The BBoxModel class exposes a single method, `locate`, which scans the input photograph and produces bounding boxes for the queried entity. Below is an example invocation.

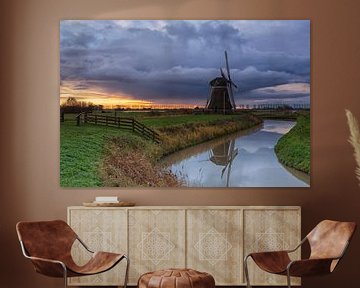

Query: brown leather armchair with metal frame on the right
[244,220,356,288]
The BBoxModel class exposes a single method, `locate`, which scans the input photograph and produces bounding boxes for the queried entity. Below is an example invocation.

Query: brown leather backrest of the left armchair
[16,220,76,260]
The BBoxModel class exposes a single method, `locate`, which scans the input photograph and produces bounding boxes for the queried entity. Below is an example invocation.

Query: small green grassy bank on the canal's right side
[275,115,310,174]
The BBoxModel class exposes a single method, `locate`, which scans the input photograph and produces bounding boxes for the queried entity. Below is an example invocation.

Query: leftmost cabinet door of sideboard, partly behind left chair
[68,209,127,286]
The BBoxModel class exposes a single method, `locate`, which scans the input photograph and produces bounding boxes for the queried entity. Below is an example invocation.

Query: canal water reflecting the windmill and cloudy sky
[162,120,310,187]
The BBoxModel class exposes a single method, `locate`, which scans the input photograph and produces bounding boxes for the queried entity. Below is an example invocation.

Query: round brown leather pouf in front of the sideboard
[138,269,215,288]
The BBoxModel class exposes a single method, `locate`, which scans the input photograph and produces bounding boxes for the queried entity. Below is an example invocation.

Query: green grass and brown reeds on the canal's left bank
[60,114,261,187]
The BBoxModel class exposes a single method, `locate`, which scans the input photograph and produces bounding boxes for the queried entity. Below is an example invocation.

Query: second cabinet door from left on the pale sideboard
[129,209,185,284]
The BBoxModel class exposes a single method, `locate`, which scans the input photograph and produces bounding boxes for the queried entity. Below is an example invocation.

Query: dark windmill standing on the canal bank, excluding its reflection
[206,51,237,113]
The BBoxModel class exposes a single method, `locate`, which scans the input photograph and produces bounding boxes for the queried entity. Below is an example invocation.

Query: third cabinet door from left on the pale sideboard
[186,209,243,285]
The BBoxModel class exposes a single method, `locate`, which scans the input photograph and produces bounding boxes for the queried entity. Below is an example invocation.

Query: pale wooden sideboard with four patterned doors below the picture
[68,206,301,286]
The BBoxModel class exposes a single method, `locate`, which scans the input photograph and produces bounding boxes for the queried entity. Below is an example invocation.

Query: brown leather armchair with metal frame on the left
[16,220,129,288]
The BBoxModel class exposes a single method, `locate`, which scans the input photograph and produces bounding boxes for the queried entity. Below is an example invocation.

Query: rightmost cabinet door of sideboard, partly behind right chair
[244,209,301,285]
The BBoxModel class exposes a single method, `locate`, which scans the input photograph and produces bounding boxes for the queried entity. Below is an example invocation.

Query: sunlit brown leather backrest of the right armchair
[306,220,356,260]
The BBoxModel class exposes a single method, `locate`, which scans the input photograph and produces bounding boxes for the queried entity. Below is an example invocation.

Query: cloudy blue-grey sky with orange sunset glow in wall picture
[60,20,310,106]
